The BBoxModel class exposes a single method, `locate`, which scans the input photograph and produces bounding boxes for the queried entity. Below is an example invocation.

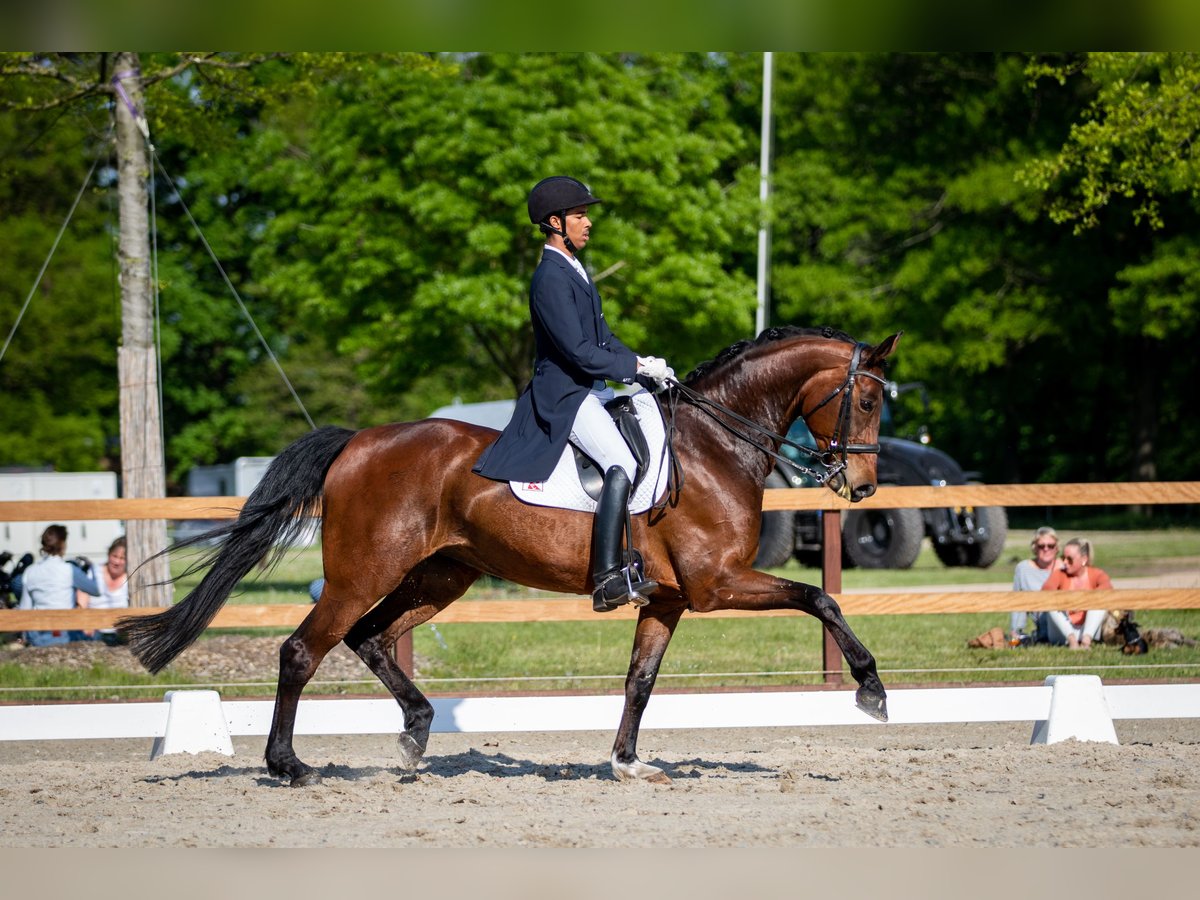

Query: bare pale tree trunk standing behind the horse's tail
[115,53,173,606]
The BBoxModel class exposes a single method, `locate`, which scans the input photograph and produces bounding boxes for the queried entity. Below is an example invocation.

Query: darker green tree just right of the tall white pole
[748,54,1080,479]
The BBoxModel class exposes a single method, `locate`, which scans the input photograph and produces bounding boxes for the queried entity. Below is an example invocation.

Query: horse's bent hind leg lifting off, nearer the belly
[346,556,480,770]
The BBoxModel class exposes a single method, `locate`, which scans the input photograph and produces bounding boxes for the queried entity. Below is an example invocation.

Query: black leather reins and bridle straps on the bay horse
[653,343,887,518]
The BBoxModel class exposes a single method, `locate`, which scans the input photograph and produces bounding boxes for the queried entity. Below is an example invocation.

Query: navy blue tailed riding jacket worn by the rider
[472,250,637,481]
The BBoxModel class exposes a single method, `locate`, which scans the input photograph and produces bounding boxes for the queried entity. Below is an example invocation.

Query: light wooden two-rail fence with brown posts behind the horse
[0,481,1200,683]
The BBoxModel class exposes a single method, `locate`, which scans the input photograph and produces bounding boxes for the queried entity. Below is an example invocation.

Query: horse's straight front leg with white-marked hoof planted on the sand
[612,604,684,785]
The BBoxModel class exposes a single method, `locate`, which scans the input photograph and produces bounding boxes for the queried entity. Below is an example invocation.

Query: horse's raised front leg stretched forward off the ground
[689,569,888,722]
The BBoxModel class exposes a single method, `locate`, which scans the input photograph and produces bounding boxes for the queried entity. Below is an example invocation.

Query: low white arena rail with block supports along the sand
[0,676,1200,756]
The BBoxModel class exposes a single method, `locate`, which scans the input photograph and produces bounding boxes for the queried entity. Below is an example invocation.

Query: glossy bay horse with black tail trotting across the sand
[118,328,900,786]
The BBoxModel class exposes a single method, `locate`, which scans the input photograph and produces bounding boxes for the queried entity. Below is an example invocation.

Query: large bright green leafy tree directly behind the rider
[206,54,755,414]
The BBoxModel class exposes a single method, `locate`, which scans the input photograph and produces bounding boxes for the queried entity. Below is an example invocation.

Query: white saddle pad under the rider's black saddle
[509,391,667,512]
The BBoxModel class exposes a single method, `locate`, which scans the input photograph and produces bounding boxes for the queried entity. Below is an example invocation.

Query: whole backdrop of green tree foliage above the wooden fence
[0,53,1200,487]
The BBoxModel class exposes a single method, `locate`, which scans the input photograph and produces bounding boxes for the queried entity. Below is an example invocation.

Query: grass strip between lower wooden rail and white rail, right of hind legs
[414,610,1200,691]
